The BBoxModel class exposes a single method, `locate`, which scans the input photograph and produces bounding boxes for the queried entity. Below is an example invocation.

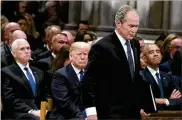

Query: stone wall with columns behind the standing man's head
[67,0,182,39]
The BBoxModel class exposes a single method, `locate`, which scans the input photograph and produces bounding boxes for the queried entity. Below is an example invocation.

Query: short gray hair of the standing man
[115,5,135,23]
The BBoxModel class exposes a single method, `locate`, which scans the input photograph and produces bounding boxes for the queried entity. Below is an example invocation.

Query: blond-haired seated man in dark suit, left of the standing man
[50,42,90,120]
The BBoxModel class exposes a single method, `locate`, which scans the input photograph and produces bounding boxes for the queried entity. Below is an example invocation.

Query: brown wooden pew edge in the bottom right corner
[142,111,182,120]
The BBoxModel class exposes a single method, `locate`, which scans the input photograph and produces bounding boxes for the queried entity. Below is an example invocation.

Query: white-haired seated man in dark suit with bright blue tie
[1,39,46,120]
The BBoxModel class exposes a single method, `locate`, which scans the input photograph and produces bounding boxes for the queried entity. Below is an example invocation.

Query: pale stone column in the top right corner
[170,1,182,30]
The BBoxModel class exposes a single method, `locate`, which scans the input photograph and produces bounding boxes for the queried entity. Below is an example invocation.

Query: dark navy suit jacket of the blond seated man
[50,64,83,120]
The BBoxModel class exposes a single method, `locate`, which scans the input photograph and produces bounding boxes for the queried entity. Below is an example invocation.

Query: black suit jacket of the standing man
[82,32,146,119]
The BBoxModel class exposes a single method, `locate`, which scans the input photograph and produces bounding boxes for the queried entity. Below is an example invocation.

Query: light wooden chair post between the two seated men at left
[40,98,53,120]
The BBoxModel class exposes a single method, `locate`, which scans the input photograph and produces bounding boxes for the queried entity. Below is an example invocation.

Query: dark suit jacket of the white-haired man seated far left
[1,63,46,118]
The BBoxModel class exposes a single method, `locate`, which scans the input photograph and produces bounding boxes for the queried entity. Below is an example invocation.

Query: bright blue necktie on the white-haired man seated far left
[24,67,36,95]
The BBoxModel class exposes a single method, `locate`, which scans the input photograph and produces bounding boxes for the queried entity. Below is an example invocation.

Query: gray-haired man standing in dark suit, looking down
[82,5,148,120]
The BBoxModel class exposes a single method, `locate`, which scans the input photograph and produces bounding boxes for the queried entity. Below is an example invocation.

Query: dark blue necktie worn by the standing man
[125,40,134,78]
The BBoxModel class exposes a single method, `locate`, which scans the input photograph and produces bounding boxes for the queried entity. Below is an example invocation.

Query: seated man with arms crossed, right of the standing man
[142,44,181,108]
